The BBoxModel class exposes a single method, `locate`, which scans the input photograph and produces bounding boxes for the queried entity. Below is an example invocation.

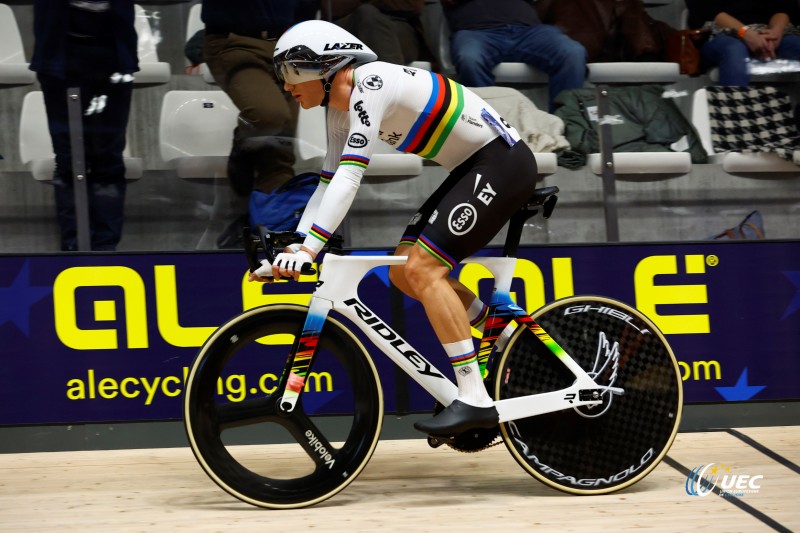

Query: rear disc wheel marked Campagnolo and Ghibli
[493,296,683,494]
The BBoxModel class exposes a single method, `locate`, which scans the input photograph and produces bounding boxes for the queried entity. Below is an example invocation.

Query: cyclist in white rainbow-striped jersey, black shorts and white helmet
[260,20,537,436]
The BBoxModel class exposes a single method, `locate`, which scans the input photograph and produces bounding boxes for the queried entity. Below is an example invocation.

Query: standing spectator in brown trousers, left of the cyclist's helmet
[201,0,319,248]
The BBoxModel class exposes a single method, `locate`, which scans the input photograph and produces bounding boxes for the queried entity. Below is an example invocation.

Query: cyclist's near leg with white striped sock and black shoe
[403,245,498,435]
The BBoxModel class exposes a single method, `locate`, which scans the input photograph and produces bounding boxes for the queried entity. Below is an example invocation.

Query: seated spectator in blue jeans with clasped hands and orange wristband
[686,0,800,86]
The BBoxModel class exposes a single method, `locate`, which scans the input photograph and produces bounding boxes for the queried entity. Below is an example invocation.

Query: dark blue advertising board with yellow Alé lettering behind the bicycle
[0,241,800,425]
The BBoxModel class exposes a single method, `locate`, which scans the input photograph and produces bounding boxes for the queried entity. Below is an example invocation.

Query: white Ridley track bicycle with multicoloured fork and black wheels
[184,187,683,509]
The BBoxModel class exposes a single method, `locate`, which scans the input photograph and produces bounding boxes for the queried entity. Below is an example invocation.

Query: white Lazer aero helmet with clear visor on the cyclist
[273,20,378,85]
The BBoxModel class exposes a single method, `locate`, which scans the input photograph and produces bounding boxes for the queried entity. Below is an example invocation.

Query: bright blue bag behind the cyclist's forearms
[249,172,319,231]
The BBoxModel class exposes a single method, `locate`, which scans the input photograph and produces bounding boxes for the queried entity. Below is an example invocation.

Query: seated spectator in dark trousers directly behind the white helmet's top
[322,0,440,71]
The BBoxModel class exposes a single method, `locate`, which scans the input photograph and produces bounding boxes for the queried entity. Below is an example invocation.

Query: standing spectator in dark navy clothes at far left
[30,0,139,251]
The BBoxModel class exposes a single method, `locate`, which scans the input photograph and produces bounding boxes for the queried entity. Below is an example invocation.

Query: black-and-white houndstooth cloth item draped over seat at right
[706,86,800,162]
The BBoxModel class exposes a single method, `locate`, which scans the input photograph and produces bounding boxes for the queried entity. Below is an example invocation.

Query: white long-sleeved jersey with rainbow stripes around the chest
[298,62,519,252]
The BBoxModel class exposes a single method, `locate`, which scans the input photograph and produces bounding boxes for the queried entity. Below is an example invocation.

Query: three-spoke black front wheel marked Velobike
[184,304,383,509]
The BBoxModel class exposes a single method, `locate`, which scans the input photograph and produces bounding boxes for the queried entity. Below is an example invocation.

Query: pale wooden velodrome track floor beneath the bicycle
[0,426,800,532]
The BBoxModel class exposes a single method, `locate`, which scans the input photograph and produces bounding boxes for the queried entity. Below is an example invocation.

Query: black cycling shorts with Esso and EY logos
[400,137,537,269]
